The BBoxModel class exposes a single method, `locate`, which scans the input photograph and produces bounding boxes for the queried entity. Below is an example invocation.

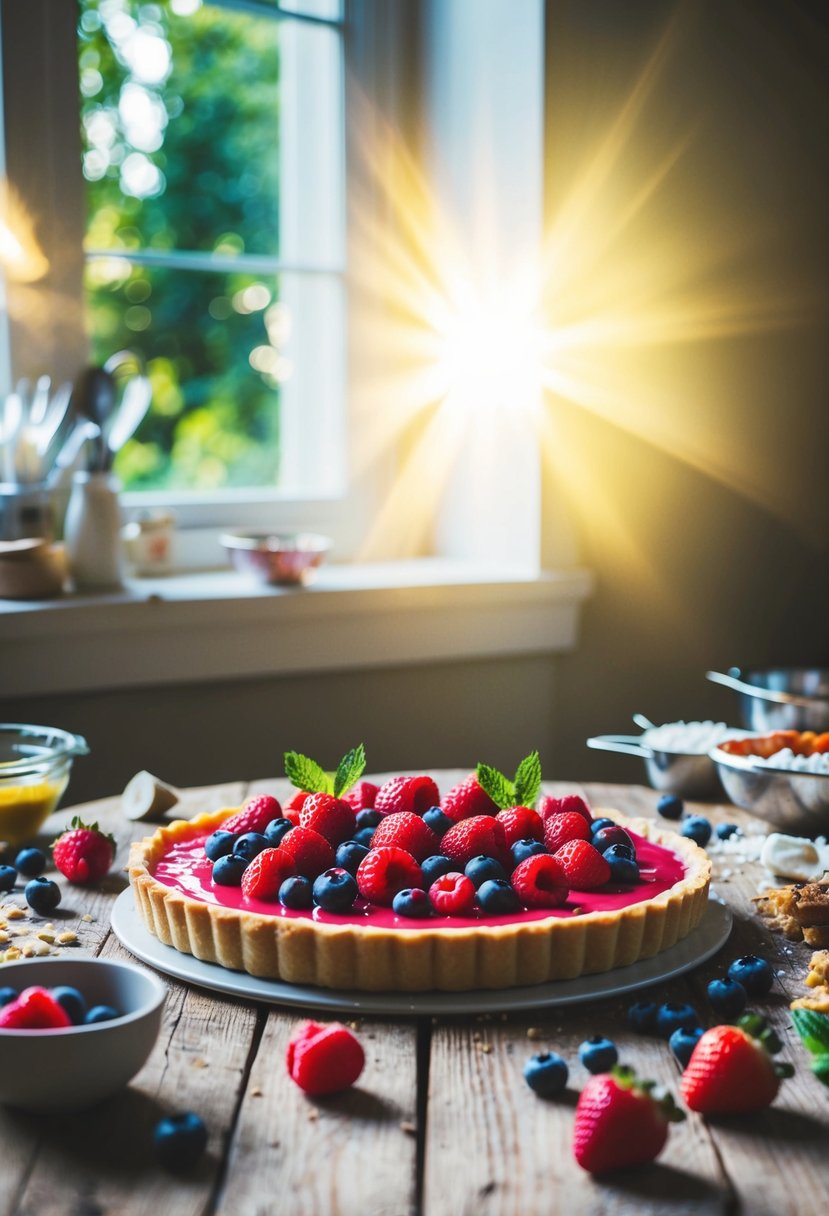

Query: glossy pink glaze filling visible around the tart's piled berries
[154,832,686,931]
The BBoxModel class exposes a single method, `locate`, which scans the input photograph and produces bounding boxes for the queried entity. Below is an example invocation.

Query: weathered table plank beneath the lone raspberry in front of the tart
[216,1010,417,1216]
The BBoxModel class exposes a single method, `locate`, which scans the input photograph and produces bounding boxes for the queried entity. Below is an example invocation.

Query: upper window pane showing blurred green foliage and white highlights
[80,0,282,254]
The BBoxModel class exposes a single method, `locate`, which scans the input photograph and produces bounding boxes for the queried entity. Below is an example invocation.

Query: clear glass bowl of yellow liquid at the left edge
[0,722,89,845]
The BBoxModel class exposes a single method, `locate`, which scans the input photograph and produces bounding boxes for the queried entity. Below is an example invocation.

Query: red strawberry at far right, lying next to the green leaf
[679,1013,794,1115]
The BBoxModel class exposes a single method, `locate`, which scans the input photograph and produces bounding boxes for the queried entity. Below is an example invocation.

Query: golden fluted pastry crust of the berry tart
[129,807,711,992]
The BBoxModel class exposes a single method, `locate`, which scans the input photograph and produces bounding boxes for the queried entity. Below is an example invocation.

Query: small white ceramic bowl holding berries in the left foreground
[0,958,167,1111]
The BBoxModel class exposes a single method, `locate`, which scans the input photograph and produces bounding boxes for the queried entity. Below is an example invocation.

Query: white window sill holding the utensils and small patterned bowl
[0,559,592,697]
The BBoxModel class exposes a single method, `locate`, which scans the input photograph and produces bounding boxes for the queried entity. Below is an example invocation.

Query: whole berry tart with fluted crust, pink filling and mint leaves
[129,747,710,992]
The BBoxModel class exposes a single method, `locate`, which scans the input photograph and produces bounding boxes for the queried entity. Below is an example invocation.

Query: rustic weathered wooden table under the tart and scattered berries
[0,773,829,1216]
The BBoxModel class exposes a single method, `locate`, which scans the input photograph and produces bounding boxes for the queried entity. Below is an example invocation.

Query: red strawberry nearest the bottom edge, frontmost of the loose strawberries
[573,1066,686,1173]
